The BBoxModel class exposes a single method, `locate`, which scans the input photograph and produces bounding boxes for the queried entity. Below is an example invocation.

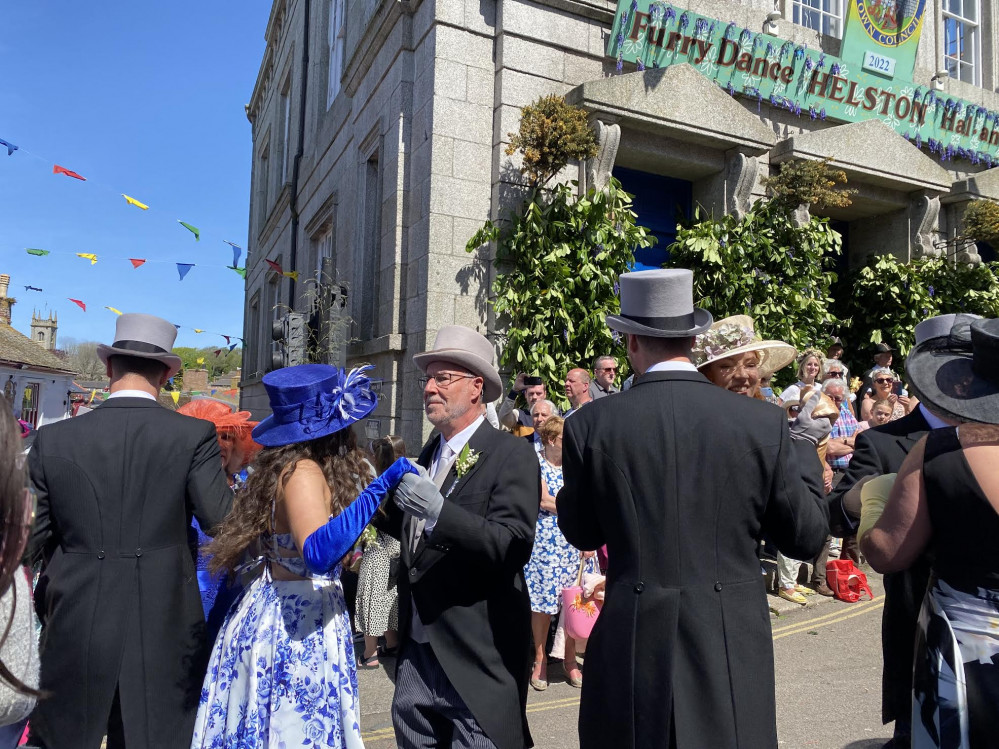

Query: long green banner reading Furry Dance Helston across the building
[607,0,999,167]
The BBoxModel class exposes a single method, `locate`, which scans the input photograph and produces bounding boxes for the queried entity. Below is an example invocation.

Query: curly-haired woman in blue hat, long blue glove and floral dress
[192,364,415,749]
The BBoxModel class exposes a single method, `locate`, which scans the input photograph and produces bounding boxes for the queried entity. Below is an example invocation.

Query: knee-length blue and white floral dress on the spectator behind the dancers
[524,453,580,614]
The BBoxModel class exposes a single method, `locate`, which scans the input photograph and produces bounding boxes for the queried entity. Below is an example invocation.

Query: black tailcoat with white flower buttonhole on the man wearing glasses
[376,421,541,749]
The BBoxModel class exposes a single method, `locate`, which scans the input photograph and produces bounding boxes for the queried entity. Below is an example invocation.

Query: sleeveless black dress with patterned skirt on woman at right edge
[912,428,999,749]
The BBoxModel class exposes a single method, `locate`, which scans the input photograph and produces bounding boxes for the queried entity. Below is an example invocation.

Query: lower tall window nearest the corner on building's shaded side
[352,151,382,341]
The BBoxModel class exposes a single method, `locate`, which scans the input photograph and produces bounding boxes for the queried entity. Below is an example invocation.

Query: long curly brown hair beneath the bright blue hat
[206,427,374,573]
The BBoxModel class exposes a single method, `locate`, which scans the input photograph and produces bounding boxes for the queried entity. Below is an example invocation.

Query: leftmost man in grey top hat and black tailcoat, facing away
[28,314,232,749]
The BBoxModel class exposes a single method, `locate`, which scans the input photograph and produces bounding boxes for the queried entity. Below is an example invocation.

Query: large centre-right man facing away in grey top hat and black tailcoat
[557,269,830,749]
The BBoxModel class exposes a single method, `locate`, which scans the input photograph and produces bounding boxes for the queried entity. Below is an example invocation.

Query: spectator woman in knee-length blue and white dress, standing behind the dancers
[524,416,583,692]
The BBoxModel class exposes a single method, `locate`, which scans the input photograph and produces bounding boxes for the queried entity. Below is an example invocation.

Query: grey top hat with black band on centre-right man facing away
[607,268,712,338]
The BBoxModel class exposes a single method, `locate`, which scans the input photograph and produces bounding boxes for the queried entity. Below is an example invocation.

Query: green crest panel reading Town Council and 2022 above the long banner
[839,0,926,79]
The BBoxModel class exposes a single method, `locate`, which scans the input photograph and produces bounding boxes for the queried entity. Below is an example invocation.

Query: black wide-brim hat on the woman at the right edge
[905,315,999,424]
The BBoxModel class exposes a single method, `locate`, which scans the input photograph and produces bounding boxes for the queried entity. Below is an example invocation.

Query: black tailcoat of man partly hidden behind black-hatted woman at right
[829,408,930,723]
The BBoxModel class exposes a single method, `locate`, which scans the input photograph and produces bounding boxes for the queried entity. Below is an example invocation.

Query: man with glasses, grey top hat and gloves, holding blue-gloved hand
[384,325,541,749]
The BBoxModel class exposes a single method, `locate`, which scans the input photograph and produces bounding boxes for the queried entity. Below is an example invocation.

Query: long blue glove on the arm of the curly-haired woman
[302,458,419,575]
